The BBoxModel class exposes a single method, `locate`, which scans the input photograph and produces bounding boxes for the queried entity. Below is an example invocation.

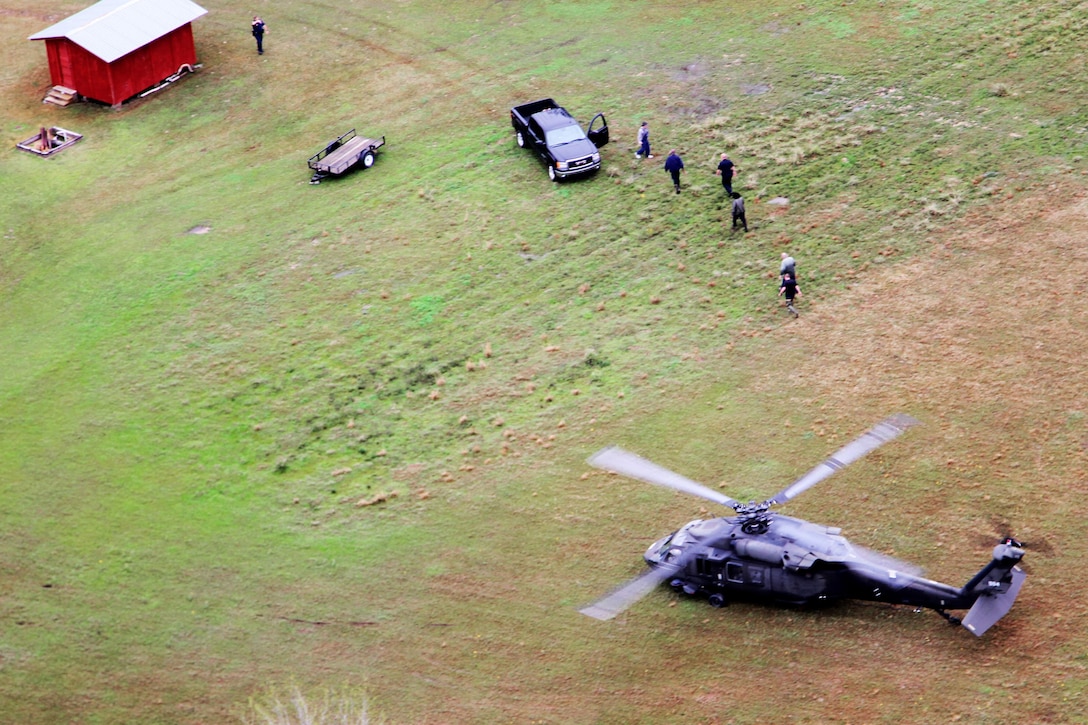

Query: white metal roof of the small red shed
[28,0,208,63]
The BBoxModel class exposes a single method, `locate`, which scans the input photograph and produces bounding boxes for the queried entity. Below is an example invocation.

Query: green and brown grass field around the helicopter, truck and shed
[0,0,1088,724]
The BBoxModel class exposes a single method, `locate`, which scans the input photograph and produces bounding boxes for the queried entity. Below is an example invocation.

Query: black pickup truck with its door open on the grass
[510,98,608,181]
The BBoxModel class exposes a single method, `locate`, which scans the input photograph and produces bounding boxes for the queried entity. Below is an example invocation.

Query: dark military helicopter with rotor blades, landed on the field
[581,414,1027,636]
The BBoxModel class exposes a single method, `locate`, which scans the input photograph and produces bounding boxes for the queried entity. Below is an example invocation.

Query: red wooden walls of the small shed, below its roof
[46,23,197,105]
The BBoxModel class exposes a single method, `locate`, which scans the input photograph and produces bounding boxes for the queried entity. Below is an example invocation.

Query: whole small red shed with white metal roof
[29,0,208,106]
